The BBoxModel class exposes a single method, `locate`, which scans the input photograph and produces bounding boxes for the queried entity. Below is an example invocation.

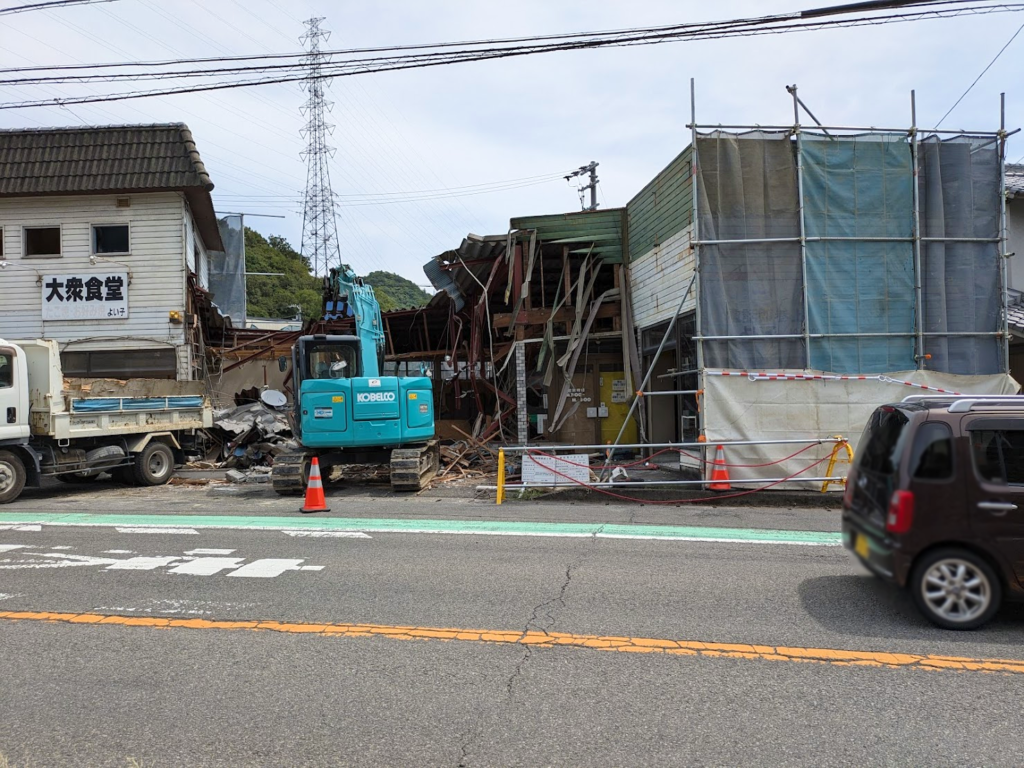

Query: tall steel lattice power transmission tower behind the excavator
[299,16,341,275]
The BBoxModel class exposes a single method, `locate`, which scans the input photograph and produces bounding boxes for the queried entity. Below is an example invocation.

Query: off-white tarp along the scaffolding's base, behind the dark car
[696,371,1020,489]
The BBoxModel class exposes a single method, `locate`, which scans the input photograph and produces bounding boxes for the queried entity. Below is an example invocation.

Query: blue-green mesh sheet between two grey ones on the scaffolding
[801,134,916,374]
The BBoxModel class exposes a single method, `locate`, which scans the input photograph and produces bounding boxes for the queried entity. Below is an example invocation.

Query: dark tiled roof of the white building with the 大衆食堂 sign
[0,123,213,197]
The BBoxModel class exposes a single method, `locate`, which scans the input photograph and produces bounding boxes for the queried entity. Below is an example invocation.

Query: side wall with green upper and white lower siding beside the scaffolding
[626,147,696,329]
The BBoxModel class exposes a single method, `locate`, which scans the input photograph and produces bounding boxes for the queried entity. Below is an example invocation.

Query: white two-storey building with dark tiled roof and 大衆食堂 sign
[0,123,223,380]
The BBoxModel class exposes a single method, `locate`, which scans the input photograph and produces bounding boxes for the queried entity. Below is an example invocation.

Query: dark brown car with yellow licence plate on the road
[843,395,1024,630]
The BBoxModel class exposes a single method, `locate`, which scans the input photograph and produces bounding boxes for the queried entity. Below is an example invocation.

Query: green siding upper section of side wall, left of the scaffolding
[626,146,693,261]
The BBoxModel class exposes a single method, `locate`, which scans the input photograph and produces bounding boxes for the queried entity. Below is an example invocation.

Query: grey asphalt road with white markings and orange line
[0,486,1024,768]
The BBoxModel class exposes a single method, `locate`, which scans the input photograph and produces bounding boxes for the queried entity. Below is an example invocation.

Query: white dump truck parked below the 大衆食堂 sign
[0,339,213,504]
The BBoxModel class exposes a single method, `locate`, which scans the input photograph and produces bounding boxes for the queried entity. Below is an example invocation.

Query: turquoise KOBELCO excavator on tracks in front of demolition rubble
[271,267,439,495]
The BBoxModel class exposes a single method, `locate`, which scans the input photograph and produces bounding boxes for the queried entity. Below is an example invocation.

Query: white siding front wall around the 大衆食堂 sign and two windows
[0,193,191,371]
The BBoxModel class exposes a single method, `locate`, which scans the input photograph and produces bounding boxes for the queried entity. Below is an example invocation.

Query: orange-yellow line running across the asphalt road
[0,610,1024,675]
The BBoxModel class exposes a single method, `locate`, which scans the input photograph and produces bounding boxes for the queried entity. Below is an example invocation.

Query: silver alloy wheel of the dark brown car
[909,549,1002,630]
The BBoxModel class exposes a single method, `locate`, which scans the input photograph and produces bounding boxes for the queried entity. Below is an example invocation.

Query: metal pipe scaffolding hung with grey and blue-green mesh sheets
[687,80,1016,442]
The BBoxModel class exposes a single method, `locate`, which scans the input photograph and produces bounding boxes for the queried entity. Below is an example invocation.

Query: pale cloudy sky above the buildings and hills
[0,0,1024,286]
